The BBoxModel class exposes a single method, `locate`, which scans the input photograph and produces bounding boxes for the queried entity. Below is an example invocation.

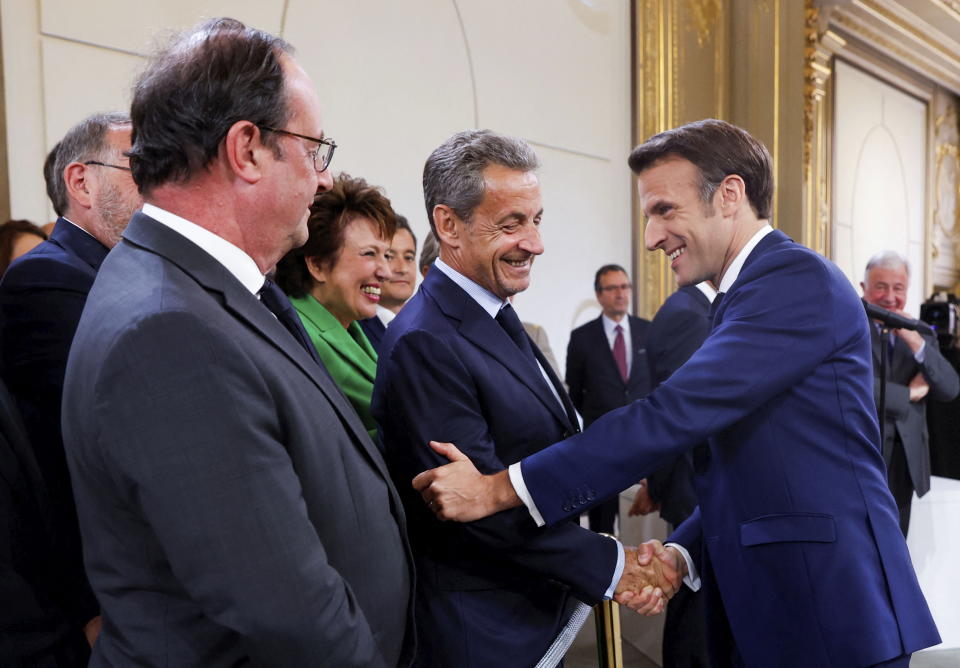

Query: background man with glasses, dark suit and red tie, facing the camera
[567,264,650,534]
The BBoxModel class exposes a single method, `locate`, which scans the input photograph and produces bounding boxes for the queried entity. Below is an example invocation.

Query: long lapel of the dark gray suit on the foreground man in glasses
[123,212,389,479]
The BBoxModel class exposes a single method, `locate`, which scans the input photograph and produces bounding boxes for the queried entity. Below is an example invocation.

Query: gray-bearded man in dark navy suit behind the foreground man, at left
[0,113,141,665]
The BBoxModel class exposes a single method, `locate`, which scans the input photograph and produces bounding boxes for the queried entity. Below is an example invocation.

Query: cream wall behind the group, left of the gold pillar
[0,0,631,365]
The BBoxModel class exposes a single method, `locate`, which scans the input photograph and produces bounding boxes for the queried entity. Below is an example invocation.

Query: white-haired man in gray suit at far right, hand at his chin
[860,251,960,536]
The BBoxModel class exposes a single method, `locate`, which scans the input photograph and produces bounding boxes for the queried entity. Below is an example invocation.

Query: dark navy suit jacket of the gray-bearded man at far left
[0,218,108,629]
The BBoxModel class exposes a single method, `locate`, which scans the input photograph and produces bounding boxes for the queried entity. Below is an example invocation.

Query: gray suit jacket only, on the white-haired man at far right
[870,323,960,496]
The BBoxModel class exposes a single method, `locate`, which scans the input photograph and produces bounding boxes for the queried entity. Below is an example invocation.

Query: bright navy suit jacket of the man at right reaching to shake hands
[522,231,940,668]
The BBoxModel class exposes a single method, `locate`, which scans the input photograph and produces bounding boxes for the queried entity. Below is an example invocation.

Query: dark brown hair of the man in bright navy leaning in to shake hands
[627,118,773,220]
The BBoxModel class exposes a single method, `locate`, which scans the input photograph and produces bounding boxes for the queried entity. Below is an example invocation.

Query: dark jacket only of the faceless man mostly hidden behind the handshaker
[647,285,711,526]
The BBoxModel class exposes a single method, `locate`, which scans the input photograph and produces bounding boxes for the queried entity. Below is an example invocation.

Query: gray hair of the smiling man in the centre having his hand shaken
[423,130,540,234]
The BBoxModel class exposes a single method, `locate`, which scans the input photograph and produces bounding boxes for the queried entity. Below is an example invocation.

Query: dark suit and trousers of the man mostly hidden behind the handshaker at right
[647,285,711,668]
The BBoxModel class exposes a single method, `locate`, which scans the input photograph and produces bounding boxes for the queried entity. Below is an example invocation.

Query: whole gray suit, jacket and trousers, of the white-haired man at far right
[870,325,960,536]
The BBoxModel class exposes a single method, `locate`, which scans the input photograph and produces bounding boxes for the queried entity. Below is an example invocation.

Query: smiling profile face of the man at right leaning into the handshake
[637,158,749,286]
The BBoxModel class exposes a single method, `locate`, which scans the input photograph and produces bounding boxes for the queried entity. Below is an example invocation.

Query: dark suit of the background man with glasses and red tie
[566,315,652,533]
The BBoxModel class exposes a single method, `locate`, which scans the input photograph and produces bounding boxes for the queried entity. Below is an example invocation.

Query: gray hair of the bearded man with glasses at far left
[43,111,130,216]
